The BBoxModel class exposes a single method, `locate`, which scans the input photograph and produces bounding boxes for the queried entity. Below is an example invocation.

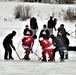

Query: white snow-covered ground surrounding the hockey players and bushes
[0,2,76,75]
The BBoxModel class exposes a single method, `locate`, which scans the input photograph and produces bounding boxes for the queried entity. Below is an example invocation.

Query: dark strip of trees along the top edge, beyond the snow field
[0,0,76,4]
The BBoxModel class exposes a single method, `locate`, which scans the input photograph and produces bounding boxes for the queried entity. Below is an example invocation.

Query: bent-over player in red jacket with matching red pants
[39,39,54,62]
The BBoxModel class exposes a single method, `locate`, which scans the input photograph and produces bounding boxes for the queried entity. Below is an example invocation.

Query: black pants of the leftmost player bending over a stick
[3,44,12,59]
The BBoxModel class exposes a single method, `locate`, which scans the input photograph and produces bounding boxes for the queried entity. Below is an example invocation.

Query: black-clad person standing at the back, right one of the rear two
[47,16,57,35]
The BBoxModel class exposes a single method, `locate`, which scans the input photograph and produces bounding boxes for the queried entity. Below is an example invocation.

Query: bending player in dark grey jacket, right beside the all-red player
[50,35,66,61]
